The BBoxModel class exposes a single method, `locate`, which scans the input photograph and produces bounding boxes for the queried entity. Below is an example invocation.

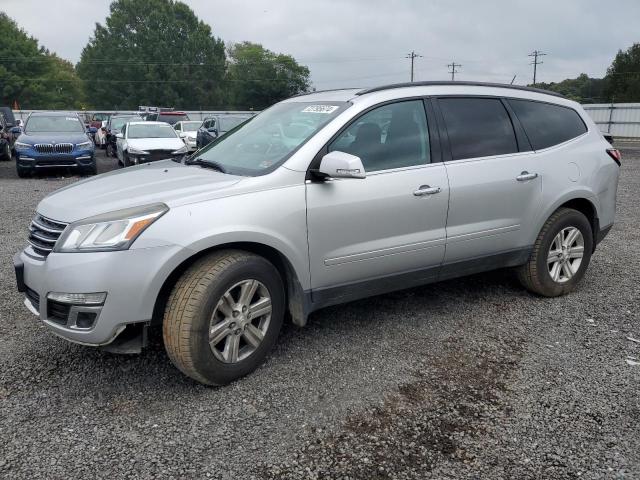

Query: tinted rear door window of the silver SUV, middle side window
[438,98,518,160]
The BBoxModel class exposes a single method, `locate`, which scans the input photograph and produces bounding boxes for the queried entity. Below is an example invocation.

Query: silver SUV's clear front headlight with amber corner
[53,203,169,252]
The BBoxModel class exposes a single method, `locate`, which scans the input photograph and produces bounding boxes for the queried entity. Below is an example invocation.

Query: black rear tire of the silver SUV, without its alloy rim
[517,208,593,297]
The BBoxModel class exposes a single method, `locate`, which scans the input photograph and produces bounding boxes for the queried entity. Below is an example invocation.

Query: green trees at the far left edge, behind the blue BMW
[0,13,82,109]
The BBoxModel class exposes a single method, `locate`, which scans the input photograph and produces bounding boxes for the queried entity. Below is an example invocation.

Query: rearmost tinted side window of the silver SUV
[509,99,587,150]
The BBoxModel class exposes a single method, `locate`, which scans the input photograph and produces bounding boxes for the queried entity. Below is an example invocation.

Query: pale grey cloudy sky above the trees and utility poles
[0,0,640,89]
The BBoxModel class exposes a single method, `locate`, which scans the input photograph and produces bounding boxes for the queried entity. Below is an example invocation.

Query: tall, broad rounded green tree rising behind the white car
[77,0,225,109]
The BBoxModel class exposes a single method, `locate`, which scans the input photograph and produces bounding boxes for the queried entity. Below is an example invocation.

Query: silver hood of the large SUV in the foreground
[37,160,243,222]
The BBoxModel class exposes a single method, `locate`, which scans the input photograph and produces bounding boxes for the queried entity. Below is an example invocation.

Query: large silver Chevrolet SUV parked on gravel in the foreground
[14,82,620,385]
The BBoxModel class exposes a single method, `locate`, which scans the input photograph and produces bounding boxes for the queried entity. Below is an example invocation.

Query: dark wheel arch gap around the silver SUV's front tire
[152,241,309,327]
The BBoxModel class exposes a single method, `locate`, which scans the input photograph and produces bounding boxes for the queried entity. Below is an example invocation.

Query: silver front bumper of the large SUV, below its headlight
[14,245,188,346]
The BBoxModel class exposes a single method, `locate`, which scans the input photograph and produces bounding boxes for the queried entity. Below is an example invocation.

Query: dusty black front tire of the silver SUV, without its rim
[163,250,285,385]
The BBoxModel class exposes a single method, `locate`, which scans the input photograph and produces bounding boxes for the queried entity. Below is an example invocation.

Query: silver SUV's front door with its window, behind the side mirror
[306,99,449,304]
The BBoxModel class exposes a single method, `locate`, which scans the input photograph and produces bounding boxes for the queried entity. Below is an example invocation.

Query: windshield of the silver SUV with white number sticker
[194,102,350,176]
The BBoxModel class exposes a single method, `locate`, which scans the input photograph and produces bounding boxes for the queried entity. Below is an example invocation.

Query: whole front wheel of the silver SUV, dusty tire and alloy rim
[163,250,285,385]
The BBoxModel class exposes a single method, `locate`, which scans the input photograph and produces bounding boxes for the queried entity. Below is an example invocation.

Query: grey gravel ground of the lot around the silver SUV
[0,146,640,480]
